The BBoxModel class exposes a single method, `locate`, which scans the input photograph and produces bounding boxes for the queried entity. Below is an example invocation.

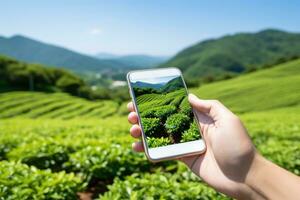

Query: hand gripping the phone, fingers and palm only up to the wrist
[128,95,259,199]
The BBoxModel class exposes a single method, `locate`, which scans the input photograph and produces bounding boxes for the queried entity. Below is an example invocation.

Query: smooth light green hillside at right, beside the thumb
[190,59,300,113]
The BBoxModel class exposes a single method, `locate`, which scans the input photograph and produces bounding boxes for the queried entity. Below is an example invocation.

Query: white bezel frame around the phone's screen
[127,67,206,162]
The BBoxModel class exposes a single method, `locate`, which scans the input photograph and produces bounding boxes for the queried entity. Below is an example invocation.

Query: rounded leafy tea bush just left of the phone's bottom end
[65,144,151,181]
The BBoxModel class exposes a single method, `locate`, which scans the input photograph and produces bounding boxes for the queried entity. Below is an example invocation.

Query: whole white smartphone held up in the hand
[127,68,206,162]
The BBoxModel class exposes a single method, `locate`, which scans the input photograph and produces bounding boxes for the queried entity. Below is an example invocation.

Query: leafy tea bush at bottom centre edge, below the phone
[100,171,228,200]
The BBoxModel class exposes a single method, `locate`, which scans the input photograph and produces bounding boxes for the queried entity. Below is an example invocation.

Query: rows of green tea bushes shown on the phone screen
[137,89,200,148]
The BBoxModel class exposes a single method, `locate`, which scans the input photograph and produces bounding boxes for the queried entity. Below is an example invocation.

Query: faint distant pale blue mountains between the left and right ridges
[95,53,169,69]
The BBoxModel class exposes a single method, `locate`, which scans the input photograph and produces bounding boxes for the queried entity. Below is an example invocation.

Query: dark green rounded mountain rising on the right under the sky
[160,29,300,78]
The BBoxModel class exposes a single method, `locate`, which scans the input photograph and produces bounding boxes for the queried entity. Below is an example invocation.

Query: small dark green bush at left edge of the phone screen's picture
[142,118,163,137]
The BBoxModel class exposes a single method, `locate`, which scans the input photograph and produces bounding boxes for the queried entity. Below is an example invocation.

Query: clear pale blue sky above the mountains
[0,0,300,55]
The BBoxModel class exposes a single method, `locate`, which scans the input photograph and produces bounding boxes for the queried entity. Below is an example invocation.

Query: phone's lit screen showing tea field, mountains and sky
[130,74,201,148]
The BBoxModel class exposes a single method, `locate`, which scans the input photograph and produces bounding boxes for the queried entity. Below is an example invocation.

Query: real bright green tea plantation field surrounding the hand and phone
[0,60,300,199]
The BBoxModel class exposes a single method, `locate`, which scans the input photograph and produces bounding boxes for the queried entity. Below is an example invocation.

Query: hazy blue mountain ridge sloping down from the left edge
[0,35,125,72]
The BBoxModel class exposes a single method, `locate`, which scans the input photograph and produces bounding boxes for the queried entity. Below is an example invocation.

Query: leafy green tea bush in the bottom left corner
[0,161,85,200]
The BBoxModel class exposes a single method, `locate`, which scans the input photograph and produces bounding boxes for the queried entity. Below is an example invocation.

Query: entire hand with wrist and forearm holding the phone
[128,94,299,199]
